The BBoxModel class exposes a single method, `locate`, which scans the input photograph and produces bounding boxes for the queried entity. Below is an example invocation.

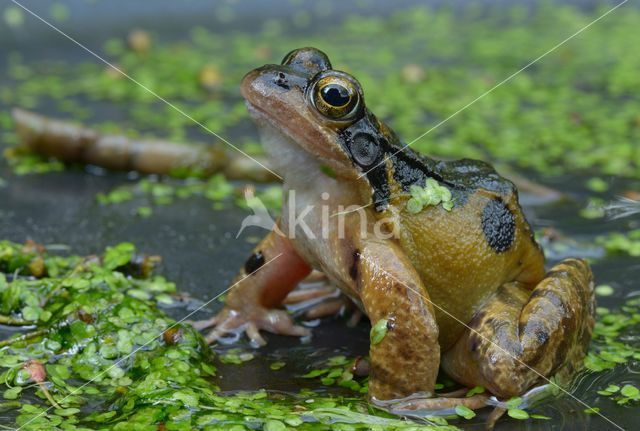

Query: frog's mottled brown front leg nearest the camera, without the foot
[351,239,440,400]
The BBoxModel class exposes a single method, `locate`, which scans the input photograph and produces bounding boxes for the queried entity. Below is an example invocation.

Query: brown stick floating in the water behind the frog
[12,108,273,182]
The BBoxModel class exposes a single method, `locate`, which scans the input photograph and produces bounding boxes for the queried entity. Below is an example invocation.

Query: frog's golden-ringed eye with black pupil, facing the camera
[311,75,361,121]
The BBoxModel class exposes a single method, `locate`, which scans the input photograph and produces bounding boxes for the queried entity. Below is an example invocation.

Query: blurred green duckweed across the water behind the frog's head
[0,2,640,181]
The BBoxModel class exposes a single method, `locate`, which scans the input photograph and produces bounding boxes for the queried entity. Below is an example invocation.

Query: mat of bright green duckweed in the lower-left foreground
[0,241,456,431]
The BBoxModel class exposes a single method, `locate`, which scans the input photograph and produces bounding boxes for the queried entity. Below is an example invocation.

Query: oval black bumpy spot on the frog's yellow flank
[482,197,516,253]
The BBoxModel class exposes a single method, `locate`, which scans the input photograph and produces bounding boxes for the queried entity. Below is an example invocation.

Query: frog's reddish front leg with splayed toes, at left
[193,232,311,345]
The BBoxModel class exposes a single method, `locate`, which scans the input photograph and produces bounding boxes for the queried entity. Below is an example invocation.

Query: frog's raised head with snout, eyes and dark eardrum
[241,48,396,182]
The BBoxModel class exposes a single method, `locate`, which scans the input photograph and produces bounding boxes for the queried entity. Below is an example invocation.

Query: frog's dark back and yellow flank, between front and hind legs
[389,152,544,348]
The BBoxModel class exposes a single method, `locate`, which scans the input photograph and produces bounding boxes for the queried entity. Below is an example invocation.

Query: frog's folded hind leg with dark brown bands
[442,259,595,398]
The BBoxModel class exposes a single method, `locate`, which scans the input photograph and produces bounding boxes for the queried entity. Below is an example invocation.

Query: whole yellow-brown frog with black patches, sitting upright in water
[195,48,594,412]
